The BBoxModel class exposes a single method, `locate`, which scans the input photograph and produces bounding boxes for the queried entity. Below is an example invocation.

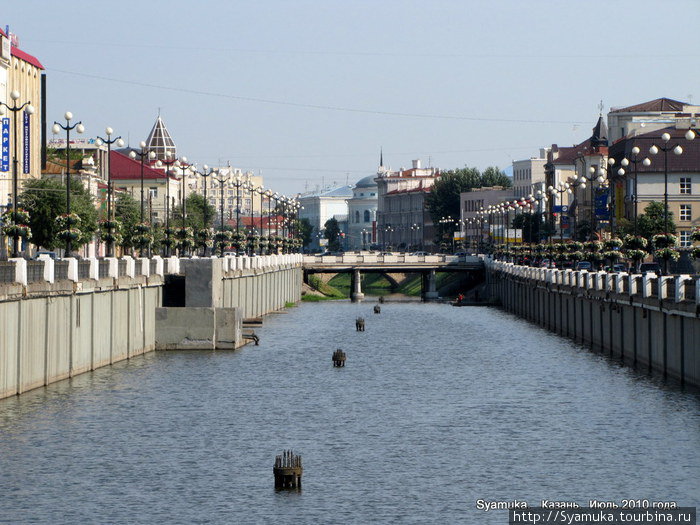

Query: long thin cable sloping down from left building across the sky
[48,68,586,124]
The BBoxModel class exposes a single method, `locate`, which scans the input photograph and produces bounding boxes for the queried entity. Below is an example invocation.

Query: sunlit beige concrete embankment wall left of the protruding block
[0,275,162,398]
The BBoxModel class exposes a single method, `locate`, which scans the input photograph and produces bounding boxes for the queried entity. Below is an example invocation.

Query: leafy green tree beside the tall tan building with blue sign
[18,176,97,250]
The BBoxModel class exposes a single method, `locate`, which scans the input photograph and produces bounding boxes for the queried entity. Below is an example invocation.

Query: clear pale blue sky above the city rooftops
[5,0,700,195]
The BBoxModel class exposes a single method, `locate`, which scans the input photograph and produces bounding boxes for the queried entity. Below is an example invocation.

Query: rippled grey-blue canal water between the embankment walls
[0,302,700,525]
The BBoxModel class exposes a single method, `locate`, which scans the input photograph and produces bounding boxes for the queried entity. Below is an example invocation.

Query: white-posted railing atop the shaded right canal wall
[485,259,700,306]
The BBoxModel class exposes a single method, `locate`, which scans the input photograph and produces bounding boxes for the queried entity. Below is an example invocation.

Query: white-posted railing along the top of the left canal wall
[0,253,302,286]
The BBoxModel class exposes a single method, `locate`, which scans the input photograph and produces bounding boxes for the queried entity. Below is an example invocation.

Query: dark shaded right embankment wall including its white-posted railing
[487,263,700,386]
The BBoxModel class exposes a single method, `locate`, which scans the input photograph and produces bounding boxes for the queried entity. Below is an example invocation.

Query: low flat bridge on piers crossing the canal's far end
[302,254,484,301]
